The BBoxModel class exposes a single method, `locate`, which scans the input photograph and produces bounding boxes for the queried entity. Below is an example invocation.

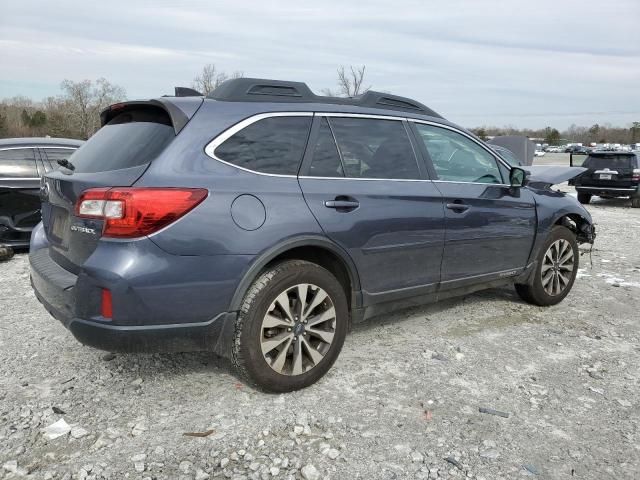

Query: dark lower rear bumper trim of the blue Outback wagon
[29,248,236,357]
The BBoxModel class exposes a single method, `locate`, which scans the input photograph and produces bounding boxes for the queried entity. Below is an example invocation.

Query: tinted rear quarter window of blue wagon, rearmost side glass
[213,116,312,175]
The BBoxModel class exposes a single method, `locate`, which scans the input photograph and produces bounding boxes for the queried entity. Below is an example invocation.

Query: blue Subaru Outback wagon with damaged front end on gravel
[29,78,595,392]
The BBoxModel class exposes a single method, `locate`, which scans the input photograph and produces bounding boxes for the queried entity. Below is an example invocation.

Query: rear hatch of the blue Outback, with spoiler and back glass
[42,98,202,273]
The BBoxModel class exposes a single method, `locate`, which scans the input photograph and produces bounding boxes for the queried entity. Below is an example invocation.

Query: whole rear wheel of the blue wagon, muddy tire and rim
[232,260,349,393]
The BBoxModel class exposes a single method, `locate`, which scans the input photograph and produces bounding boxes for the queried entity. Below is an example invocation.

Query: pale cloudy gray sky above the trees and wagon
[0,0,640,128]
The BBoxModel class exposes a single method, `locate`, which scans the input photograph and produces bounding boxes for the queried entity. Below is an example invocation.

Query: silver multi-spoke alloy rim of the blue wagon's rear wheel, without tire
[260,283,336,375]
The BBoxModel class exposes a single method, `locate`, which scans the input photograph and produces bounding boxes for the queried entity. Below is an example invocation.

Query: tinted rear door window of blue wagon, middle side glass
[329,117,421,179]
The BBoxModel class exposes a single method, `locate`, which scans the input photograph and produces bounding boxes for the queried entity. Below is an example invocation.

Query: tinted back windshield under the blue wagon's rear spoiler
[69,107,175,173]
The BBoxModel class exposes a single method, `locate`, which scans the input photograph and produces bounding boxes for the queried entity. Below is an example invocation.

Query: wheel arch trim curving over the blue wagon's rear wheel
[229,235,362,311]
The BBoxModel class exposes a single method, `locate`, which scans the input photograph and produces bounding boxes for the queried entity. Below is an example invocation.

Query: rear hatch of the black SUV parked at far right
[575,152,638,188]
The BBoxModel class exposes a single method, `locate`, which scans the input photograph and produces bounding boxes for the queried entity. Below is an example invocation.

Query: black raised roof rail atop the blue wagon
[208,78,442,118]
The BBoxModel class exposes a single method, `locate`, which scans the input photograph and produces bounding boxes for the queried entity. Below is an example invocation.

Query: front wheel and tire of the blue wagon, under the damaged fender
[515,225,580,307]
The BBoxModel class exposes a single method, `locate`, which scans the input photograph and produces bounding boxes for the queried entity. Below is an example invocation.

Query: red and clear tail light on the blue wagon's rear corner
[76,187,208,238]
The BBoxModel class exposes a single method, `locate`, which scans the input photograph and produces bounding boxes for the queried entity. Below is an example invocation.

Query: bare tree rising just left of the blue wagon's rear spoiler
[59,78,125,138]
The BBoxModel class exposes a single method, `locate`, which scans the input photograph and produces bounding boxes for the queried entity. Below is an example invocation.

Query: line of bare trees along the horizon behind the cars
[0,63,640,145]
